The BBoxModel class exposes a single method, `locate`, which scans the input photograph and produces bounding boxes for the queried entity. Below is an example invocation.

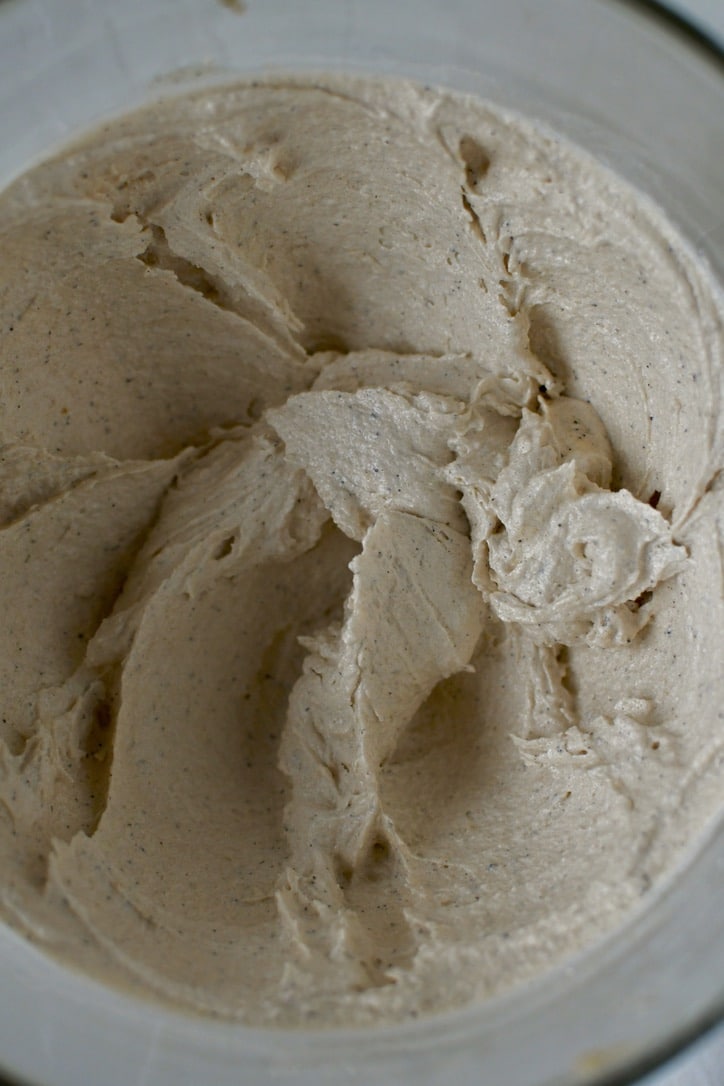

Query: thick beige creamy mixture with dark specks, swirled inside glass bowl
[0,77,724,1025]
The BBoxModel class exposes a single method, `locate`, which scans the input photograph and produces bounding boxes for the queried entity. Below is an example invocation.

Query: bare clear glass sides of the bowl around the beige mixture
[0,0,724,1086]
